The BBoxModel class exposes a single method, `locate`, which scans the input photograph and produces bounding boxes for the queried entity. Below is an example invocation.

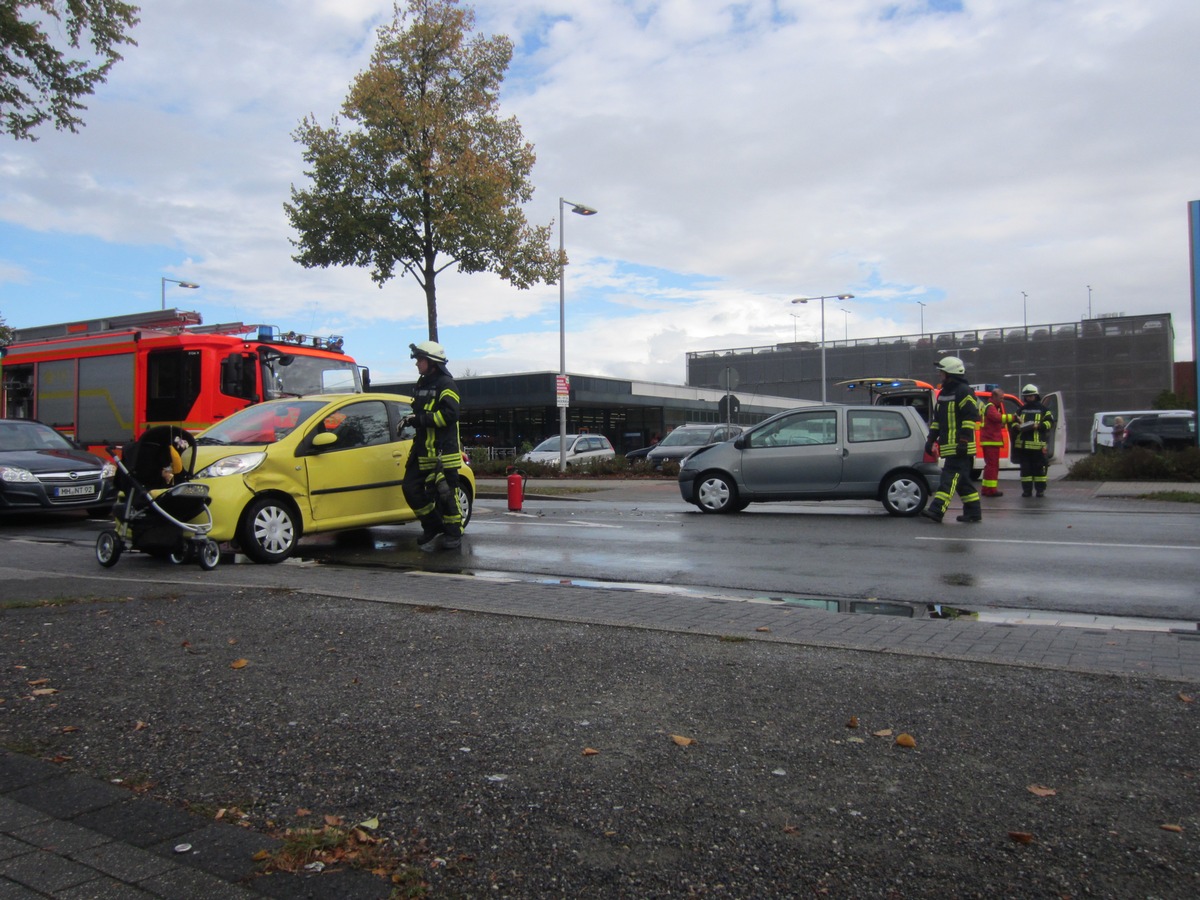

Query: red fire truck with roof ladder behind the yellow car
[0,310,366,452]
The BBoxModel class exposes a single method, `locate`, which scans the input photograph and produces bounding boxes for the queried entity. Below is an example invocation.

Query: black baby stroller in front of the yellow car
[96,425,221,571]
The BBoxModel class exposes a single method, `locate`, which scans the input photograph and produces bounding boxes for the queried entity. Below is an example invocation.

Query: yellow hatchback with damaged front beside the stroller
[184,394,475,563]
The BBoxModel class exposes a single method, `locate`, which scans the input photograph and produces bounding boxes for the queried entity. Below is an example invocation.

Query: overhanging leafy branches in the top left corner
[0,0,138,140]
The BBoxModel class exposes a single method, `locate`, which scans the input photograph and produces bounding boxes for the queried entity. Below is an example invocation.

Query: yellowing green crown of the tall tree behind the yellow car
[284,0,559,341]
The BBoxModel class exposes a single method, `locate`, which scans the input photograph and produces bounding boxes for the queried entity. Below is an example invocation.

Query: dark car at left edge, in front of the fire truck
[0,419,116,517]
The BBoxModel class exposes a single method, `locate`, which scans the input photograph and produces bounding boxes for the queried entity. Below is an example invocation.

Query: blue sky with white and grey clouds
[0,0,1200,383]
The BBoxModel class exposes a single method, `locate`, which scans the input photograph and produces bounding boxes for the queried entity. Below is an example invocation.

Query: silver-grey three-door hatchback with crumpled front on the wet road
[679,406,938,516]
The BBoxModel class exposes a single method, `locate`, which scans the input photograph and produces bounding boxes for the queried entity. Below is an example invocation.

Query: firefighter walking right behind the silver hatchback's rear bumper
[920,356,983,523]
